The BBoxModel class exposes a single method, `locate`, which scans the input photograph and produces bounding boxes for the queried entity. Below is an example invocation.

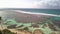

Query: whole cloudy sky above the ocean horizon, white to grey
[0,0,60,9]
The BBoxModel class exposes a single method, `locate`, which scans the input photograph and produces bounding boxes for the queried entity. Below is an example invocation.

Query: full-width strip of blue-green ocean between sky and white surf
[0,8,60,15]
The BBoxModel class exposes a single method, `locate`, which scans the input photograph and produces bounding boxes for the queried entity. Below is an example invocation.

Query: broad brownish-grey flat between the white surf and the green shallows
[0,10,51,22]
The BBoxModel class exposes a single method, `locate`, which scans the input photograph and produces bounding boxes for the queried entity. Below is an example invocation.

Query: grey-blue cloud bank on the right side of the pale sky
[36,0,60,9]
